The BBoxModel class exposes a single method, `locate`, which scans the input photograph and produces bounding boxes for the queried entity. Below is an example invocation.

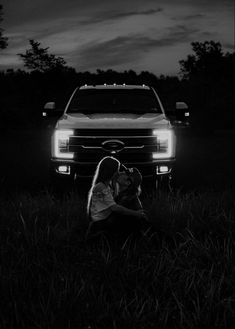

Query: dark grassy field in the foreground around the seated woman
[0,189,235,329]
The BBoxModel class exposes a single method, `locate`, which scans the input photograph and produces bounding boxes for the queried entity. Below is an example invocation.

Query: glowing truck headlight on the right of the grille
[152,129,175,159]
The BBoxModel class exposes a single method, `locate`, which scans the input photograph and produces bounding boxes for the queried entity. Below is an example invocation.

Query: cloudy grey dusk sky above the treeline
[0,0,234,75]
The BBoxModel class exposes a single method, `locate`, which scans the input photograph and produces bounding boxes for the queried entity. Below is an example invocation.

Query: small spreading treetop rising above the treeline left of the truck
[18,40,68,72]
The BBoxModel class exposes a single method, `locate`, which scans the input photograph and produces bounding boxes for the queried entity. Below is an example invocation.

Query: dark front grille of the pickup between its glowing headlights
[69,129,157,163]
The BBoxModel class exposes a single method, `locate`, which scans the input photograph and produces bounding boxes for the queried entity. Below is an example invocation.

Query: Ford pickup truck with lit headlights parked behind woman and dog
[43,84,187,187]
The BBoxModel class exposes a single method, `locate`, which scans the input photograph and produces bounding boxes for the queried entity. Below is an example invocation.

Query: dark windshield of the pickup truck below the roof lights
[67,89,162,114]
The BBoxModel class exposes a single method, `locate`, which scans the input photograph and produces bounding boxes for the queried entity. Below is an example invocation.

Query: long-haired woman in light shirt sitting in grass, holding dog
[87,157,146,233]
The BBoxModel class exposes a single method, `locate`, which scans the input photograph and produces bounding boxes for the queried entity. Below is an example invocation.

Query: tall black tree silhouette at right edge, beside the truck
[179,41,235,130]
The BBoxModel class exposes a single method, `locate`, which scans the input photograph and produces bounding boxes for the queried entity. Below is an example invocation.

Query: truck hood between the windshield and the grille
[56,113,171,129]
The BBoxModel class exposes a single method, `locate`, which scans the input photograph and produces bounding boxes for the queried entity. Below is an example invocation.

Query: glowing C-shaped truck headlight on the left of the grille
[52,130,74,159]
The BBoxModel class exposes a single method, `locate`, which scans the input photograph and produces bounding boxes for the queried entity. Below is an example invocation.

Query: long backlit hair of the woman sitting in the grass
[87,156,120,216]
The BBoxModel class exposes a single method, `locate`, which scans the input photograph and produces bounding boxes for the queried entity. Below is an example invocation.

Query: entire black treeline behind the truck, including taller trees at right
[0,41,235,129]
